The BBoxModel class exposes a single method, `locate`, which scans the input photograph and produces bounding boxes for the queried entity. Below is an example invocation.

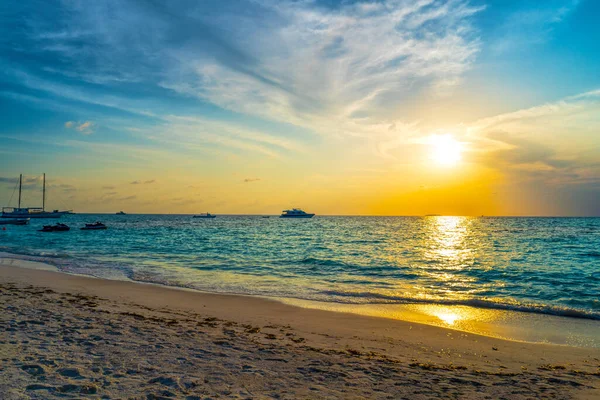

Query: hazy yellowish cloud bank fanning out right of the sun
[467,90,600,192]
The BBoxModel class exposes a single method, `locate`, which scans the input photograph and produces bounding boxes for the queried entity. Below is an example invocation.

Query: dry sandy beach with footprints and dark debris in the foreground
[0,259,600,399]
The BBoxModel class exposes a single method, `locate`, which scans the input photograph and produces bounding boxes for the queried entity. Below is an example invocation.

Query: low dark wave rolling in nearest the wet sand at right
[321,290,600,321]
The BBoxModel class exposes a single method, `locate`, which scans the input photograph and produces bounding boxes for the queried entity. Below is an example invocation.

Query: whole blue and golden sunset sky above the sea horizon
[0,0,600,215]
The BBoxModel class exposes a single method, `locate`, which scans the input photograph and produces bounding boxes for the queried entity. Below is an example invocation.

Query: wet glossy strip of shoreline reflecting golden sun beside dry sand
[0,253,600,348]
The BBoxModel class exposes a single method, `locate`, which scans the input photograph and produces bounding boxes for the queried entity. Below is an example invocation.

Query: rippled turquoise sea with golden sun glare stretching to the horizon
[0,215,600,320]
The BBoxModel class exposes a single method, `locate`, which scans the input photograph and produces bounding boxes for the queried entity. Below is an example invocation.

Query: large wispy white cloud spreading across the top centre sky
[162,0,480,131]
